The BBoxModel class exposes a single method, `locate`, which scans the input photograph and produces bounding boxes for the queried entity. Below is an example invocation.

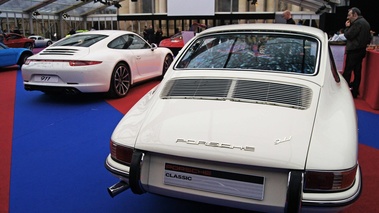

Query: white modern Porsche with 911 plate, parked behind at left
[22,30,173,98]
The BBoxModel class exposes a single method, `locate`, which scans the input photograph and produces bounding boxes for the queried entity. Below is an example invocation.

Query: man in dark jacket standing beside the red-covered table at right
[343,7,371,98]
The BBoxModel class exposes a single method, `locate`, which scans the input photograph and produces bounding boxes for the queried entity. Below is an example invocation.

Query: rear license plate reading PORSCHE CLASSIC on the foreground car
[164,163,265,200]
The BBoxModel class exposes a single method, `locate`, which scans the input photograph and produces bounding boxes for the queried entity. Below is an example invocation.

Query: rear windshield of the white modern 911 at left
[52,34,107,47]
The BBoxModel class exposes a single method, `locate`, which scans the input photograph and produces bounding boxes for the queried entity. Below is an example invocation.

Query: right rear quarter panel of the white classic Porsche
[306,41,358,170]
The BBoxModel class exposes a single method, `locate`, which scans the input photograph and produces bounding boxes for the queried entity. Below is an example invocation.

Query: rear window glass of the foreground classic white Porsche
[176,33,319,74]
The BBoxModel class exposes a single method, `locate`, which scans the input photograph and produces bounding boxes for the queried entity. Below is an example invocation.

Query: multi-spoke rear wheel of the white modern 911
[108,63,131,98]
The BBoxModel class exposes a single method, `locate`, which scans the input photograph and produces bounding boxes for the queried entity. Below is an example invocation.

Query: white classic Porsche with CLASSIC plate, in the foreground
[105,24,362,212]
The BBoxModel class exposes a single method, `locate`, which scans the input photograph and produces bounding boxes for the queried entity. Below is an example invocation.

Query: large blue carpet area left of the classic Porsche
[9,72,246,213]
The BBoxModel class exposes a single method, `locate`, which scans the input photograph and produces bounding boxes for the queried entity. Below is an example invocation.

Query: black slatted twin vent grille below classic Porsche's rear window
[161,79,312,109]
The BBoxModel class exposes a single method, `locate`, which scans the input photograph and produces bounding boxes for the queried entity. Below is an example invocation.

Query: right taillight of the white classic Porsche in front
[304,166,357,191]
